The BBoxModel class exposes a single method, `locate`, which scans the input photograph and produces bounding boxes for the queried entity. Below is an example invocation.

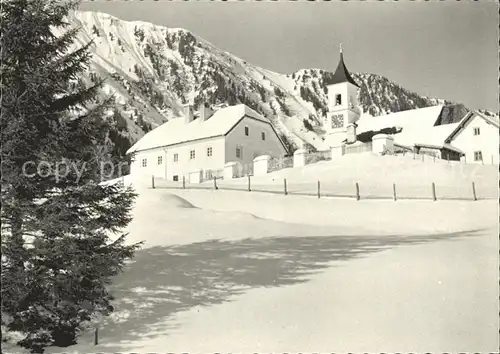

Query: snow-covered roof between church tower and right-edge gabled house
[357,105,459,146]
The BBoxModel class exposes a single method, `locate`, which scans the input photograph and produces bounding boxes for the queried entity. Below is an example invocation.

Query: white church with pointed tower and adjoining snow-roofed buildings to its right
[324,47,499,164]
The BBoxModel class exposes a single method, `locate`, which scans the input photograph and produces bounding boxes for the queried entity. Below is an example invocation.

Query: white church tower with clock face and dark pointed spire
[325,44,361,147]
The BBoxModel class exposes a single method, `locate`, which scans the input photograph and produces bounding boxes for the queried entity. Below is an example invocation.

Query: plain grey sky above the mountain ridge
[80,0,499,112]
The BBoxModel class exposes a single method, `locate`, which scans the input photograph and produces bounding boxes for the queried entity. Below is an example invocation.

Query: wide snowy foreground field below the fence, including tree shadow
[3,165,499,353]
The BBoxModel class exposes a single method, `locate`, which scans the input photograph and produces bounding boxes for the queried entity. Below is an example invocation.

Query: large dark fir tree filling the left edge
[0,0,139,353]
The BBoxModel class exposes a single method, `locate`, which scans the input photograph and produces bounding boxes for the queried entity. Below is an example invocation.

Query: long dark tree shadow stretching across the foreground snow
[88,231,478,351]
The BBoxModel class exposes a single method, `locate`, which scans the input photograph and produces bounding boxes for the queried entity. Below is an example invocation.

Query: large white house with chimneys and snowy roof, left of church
[127,104,287,181]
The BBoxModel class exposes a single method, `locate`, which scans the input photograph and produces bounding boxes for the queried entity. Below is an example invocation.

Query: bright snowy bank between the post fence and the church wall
[154,153,498,200]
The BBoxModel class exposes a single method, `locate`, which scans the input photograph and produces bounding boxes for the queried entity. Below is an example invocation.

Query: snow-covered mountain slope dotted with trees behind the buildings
[67,12,496,149]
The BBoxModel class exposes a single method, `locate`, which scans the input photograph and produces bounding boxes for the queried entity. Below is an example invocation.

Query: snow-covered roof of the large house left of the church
[127,104,270,154]
